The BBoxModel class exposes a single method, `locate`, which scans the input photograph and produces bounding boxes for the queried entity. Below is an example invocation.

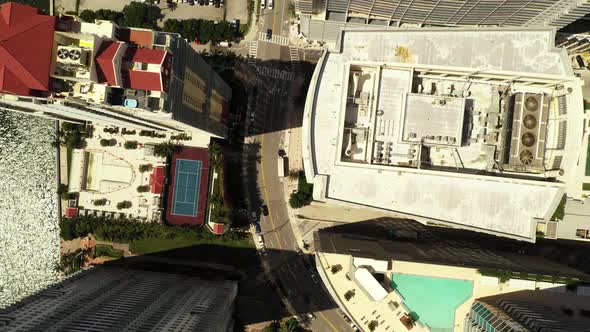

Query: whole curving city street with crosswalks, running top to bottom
[240,0,351,332]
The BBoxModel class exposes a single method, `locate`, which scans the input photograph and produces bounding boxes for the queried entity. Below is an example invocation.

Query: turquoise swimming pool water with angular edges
[391,273,473,331]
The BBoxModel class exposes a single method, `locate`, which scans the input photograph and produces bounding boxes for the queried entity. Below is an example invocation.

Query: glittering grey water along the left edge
[0,111,59,308]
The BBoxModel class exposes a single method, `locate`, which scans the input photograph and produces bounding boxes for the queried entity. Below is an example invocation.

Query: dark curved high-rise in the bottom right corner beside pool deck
[464,290,590,332]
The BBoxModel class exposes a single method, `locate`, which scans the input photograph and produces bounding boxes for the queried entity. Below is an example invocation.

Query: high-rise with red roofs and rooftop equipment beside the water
[0,3,231,137]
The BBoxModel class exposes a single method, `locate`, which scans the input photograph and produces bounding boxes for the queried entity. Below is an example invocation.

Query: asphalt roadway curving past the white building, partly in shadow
[246,12,351,326]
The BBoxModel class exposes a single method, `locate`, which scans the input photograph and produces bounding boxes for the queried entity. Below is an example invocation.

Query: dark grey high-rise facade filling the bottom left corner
[0,266,237,332]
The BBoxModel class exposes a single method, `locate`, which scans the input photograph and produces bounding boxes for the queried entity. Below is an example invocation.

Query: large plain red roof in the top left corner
[0,2,55,95]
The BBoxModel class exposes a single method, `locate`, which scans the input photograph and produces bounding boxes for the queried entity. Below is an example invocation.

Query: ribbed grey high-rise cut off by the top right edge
[297,0,590,41]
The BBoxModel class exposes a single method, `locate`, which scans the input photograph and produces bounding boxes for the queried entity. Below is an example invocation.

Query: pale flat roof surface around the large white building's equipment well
[303,28,583,241]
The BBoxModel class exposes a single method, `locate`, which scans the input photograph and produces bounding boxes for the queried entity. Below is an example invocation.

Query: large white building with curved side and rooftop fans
[303,28,586,241]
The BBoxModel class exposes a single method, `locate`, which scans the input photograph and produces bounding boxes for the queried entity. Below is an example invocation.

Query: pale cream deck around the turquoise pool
[316,252,552,332]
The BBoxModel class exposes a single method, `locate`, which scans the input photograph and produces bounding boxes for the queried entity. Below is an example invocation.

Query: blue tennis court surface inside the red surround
[172,159,202,217]
